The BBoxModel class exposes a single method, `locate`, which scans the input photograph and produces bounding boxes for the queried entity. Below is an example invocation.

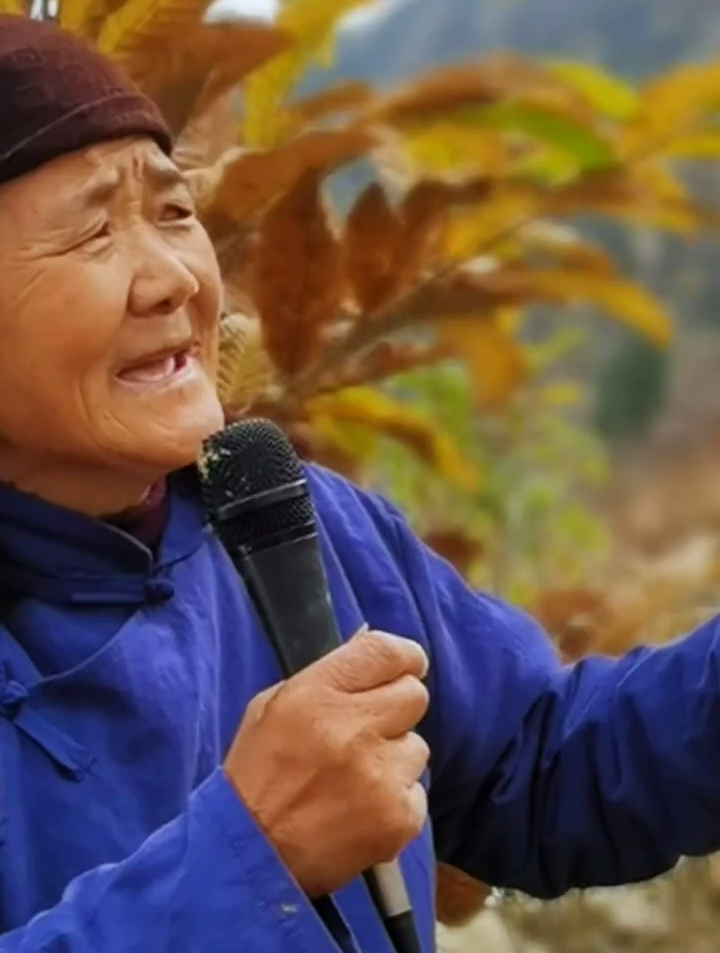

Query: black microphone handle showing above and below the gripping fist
[236,529,422,953]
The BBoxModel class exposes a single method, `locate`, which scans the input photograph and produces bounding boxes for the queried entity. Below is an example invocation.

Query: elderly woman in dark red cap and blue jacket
[0,17,720,953]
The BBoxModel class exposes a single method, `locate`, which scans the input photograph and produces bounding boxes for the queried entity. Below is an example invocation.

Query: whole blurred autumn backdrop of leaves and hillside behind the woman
[12,0,720,953]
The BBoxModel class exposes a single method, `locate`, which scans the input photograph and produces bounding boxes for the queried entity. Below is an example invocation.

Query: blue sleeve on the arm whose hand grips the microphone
[0,770,339,953]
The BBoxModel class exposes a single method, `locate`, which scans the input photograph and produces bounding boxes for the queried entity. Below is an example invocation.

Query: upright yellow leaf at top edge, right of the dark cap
[243,0,372,148]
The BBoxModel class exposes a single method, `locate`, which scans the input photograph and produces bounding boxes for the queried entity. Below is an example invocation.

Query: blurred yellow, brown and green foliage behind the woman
[11,0,720,940]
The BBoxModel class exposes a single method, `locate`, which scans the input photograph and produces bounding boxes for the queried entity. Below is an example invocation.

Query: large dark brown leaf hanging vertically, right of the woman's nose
[250,172,343,376]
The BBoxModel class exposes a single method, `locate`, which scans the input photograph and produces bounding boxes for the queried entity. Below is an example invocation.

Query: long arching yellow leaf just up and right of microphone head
[307,387,479,493]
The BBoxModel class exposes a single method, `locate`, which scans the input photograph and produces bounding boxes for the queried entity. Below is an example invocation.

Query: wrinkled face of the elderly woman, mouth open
[0,140,222,494]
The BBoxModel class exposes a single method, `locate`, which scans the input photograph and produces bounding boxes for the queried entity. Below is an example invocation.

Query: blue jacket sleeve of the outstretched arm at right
[374,490,720,898]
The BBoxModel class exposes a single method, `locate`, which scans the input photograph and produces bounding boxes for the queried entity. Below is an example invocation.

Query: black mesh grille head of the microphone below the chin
[198,418,314,552]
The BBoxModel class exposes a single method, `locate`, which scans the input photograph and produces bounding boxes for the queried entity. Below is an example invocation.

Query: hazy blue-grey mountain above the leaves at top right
[320,0,720,84]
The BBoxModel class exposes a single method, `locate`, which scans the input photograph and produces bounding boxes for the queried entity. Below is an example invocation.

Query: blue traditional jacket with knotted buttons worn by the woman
[0,468,720,953]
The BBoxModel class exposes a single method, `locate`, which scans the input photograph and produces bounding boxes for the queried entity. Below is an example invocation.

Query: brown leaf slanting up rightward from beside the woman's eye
[203,130,375,230]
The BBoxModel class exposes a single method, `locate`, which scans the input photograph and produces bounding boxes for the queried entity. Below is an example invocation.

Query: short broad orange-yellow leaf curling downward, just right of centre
[435,315,528,411]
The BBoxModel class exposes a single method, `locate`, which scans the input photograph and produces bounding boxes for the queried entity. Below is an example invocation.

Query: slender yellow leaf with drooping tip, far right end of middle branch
[529,270,672,347]
